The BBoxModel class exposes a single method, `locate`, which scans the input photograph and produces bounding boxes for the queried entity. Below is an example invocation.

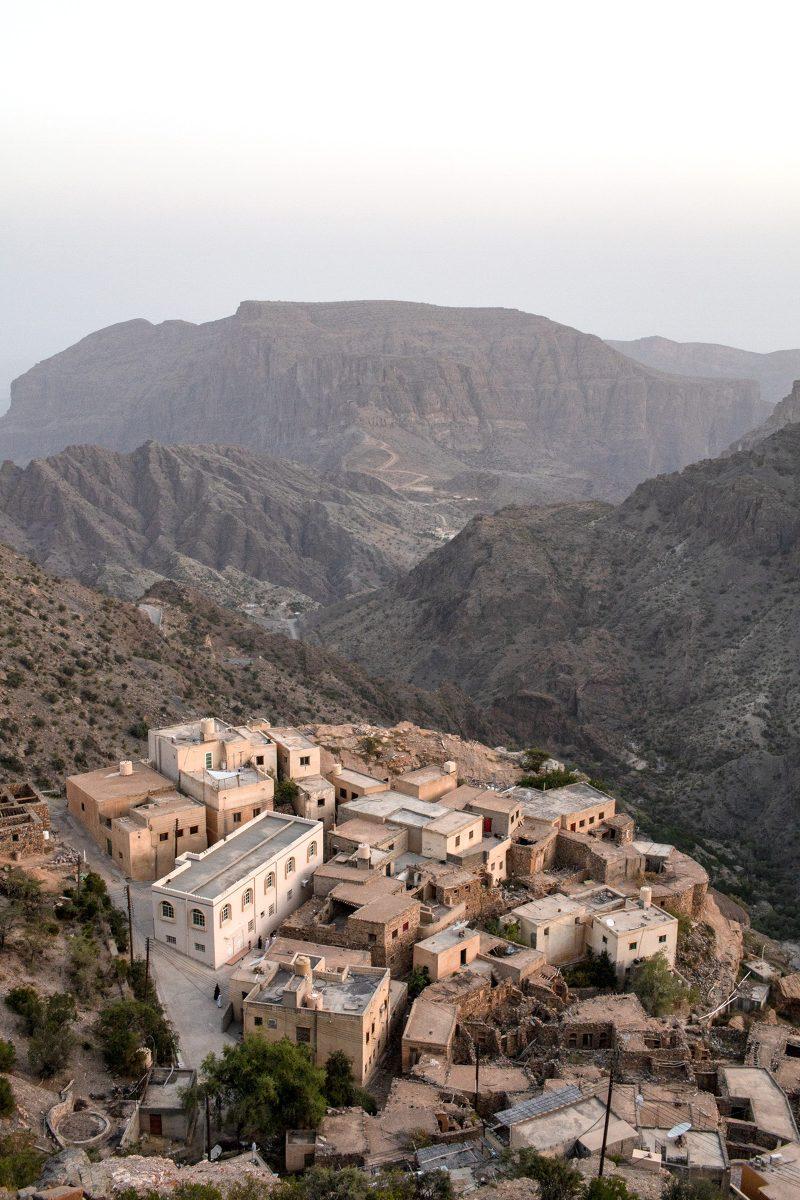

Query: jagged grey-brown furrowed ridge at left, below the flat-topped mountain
[0,442,468,604]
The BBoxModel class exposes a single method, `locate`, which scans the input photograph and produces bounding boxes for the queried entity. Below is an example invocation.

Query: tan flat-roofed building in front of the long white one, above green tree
[242,954,390,1085]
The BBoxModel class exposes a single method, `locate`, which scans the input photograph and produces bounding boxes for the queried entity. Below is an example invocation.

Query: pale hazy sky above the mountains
[0,0,800,396]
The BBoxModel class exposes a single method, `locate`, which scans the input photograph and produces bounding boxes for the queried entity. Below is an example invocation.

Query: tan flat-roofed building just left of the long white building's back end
[106,791,207,880]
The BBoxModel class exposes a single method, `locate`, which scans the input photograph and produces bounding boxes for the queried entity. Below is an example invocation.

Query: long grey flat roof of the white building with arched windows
[155,812,323,900]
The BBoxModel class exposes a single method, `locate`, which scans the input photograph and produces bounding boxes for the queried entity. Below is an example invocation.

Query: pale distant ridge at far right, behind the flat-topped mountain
[608,337,800,404]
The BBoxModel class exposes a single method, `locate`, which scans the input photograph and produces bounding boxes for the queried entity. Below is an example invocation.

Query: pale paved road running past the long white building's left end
[52,797,236,1067]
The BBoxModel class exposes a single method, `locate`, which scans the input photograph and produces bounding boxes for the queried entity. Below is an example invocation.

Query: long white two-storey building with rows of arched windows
[151,812,323,970]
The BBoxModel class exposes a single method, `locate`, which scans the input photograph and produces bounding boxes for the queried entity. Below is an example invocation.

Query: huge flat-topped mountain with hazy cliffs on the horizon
[0,301,766,498]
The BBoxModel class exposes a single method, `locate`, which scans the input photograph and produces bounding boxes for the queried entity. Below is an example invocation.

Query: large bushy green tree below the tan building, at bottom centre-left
[201,1038,326,1145]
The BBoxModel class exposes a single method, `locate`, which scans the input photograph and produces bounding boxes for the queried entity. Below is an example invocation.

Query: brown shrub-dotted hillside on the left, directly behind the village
[0,545,494,786]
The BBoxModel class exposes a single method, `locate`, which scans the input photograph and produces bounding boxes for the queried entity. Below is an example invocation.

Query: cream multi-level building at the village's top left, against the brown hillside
[148,716,277,782]
